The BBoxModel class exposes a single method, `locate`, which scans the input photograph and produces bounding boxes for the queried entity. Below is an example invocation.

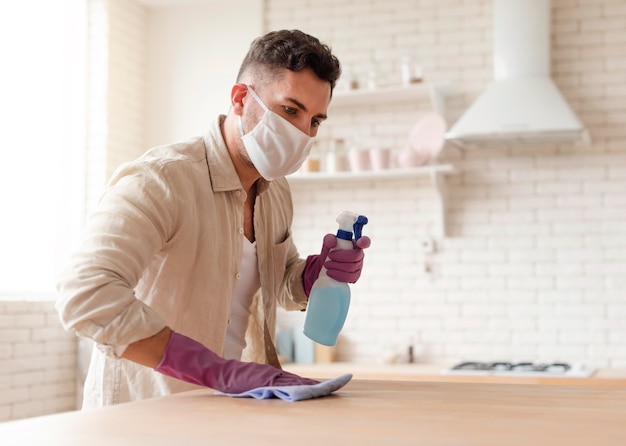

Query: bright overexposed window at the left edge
[0,0,86,298]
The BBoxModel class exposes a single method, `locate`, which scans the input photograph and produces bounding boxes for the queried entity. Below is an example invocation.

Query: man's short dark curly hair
[237,30,341,92]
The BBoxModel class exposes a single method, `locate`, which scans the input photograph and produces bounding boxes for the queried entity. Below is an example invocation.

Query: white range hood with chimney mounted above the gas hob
[446,0,589,145]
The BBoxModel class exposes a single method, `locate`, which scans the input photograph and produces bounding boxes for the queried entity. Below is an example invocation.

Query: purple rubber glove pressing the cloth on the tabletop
[154,332,318,393]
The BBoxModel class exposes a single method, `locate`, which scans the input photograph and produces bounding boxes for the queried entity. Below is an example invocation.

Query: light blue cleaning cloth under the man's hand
[222,373,352,402]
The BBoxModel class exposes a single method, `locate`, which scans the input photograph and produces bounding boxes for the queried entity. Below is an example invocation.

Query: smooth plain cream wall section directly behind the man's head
[140,0,263,147]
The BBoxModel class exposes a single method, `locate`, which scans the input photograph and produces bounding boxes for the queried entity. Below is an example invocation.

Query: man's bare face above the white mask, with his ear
[244,69,330,136]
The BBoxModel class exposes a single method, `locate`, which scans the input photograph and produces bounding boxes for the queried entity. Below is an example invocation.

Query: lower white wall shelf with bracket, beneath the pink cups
[287,164,456,238]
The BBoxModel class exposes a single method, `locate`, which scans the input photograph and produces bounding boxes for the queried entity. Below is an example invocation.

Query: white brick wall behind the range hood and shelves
[266,0,626,367]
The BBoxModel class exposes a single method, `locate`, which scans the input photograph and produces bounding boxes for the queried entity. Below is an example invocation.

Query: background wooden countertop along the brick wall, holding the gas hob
[283,362,626,387]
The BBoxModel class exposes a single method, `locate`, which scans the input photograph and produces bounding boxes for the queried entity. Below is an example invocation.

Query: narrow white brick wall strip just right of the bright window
[86,0,148,211]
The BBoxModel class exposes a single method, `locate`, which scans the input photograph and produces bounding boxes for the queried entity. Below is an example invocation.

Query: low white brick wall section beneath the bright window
[0,301,76,422]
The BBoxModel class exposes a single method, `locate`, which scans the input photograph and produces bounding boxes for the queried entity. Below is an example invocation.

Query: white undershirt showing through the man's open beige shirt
[224,237,261,359]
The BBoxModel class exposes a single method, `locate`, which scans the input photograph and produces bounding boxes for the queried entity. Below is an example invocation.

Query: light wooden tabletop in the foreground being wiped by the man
[0,380,626,446]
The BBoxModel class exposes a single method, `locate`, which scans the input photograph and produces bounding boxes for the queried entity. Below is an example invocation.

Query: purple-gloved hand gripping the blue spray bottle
[302,234,371,296]
